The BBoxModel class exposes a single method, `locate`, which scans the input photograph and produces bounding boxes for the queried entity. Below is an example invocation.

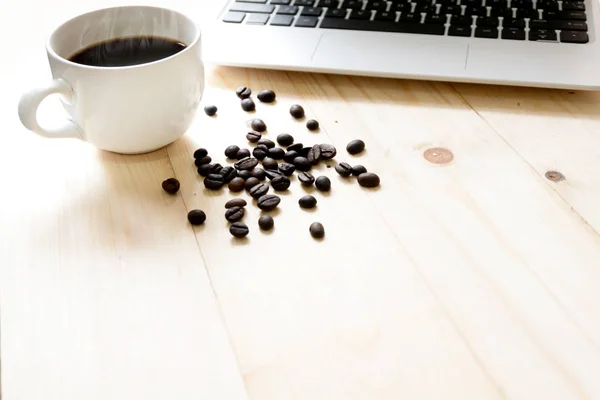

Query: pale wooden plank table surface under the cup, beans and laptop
[0,0,600,400]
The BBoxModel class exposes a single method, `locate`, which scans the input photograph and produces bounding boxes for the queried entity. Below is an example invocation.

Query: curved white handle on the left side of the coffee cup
[19,79,83,139]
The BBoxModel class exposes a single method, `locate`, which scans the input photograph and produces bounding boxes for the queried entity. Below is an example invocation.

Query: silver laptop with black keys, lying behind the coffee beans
[204,0,600,90]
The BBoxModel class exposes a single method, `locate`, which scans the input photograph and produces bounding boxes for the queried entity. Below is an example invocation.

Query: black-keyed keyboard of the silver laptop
[223,0,589,43]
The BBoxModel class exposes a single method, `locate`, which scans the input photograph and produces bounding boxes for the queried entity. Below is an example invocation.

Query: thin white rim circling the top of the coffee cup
[46,5,201,71]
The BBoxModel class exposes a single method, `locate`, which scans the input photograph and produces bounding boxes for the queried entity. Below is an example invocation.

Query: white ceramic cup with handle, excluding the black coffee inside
[19,6,204,154]
